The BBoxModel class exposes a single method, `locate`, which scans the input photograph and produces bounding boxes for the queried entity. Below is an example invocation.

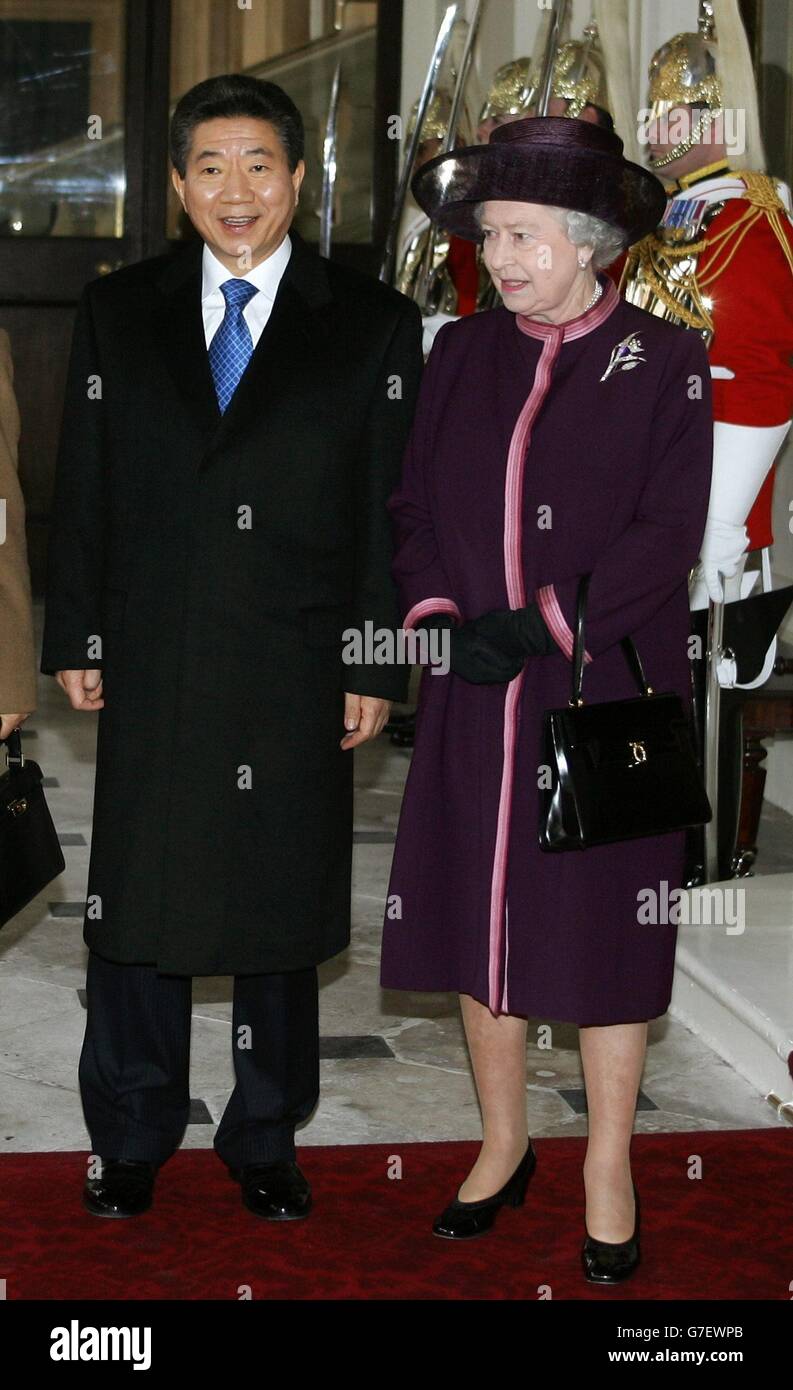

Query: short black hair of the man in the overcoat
[169,72,306,178]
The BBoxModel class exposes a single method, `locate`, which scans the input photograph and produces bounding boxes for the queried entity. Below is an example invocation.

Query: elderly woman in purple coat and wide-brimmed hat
[382,118,711,1283]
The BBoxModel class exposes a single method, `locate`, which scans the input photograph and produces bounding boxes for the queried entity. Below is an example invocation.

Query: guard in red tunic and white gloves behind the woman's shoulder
[622,0,793,883]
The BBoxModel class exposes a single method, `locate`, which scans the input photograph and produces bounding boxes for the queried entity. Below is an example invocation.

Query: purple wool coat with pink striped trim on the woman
[381,277,712,1026]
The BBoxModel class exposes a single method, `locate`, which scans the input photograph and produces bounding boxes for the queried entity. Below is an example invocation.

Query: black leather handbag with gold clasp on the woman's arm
[539,574,712,851]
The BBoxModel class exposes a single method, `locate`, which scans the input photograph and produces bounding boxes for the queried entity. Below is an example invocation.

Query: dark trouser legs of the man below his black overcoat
[79,951,319,1168]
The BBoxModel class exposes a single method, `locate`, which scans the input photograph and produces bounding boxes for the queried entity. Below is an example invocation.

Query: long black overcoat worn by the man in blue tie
[42,232,422,974]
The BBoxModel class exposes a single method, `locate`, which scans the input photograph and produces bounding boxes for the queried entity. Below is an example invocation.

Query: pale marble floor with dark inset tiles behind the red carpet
[0,622,793,1152]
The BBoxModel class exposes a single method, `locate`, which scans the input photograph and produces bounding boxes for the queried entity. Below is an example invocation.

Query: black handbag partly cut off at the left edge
[0,728,65,927]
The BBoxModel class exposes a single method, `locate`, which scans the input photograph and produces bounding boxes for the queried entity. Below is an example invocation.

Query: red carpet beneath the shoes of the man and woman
[0,1129,793,1300]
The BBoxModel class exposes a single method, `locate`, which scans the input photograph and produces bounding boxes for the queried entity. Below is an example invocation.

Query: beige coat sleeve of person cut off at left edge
[0,328,36,714]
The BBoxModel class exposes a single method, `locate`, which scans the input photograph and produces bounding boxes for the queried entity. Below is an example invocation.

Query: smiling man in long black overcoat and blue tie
[42,75,422,1219]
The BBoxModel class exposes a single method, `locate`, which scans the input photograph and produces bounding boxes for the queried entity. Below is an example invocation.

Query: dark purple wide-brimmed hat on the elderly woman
[411,115,667,245]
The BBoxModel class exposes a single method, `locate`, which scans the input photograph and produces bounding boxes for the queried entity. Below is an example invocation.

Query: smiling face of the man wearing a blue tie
[171,115,306,274]
